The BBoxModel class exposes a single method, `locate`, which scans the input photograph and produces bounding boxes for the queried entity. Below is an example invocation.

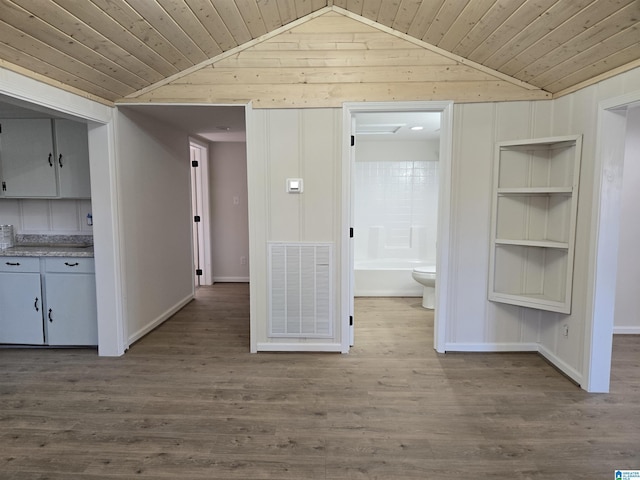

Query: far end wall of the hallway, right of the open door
[209,142,249,282]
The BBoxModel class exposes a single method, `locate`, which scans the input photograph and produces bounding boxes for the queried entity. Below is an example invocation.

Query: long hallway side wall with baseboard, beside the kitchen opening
[116,108,194,343]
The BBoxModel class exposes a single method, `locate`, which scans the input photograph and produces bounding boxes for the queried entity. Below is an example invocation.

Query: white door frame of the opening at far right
[583,91,640,393]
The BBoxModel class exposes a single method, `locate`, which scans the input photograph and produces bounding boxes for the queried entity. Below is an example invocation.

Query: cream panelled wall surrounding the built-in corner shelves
[447,69,640,383]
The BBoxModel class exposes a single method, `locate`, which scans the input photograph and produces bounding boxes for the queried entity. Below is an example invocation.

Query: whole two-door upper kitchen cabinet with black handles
[0,118,91,198]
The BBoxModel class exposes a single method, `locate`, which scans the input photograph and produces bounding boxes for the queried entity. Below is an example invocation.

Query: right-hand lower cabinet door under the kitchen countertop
[44,273,98,345]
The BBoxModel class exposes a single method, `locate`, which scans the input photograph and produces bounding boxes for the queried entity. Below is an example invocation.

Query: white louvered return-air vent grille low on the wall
[269,243,333,338]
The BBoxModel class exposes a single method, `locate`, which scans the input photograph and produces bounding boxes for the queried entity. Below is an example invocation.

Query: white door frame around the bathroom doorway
[340,101,453,353]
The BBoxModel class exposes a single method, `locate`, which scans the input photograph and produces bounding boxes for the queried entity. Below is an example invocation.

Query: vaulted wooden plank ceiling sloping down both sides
[0,0,640,104]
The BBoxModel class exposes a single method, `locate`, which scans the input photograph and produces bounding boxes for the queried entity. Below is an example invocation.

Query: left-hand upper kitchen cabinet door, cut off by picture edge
[0,119,58,197]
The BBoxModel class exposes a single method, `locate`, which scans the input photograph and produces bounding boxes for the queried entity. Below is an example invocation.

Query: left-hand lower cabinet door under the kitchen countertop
[0,273,44,345]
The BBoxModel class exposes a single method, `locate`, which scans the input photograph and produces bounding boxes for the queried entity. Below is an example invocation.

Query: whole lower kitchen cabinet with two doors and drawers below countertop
[0,257,98,346]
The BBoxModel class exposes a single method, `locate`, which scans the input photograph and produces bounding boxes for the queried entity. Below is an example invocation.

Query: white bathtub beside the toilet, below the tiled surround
[354,258,428,297]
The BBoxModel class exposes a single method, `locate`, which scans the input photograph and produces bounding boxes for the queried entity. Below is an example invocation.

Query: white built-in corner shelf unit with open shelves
[488,135,582,313]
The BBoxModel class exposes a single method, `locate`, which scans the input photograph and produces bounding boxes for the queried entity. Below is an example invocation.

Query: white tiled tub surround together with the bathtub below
[354,157,438,297]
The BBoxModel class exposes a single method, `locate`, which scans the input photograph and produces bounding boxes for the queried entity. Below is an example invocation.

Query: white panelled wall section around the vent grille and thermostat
[247,109,342,351]
